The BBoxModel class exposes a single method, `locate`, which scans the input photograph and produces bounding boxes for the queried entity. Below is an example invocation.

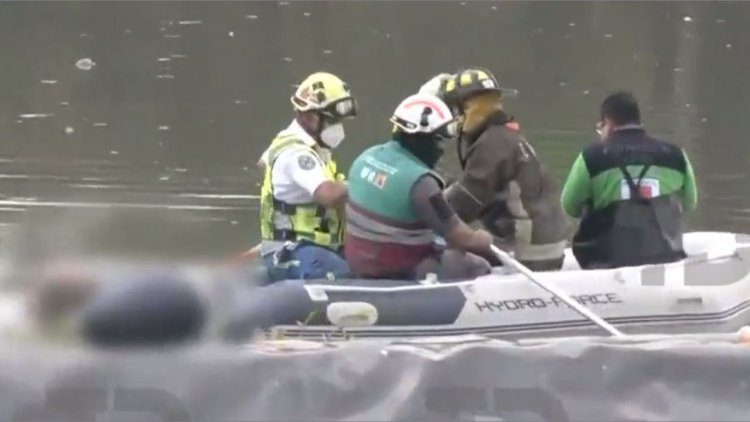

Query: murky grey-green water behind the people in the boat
[0,1,750,260]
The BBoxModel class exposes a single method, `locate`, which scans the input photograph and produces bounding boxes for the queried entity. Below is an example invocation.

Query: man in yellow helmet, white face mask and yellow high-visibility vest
[260,72,357,281]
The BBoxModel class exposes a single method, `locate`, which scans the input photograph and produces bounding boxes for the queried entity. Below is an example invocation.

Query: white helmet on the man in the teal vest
[391,94,458,139]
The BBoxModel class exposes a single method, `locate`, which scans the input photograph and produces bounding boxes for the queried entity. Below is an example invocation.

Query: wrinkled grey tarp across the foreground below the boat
[0,332,750,422]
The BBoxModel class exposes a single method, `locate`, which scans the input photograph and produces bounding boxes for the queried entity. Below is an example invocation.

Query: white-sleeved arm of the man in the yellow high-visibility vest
[284,150,349,208]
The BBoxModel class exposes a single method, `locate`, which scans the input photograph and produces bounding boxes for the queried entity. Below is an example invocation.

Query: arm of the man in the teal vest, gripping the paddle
[410,175,492,254]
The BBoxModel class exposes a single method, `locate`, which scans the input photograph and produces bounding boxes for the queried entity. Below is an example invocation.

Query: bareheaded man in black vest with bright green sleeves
[561,92,697,269]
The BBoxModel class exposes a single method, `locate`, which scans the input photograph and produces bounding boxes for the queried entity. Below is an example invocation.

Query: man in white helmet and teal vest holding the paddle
[345,94,492,281]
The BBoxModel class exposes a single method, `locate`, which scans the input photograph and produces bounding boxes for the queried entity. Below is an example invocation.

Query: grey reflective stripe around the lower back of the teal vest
[346,204,435,245]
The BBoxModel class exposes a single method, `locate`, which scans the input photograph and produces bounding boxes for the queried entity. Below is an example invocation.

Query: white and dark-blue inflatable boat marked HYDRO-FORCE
[220,232,750,340]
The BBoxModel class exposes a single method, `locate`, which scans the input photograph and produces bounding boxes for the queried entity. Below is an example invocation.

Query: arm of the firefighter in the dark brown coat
[445,133,515,224]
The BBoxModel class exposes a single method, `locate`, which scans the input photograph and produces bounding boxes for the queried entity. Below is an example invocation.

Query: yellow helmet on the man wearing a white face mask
[291,72,357,119]
